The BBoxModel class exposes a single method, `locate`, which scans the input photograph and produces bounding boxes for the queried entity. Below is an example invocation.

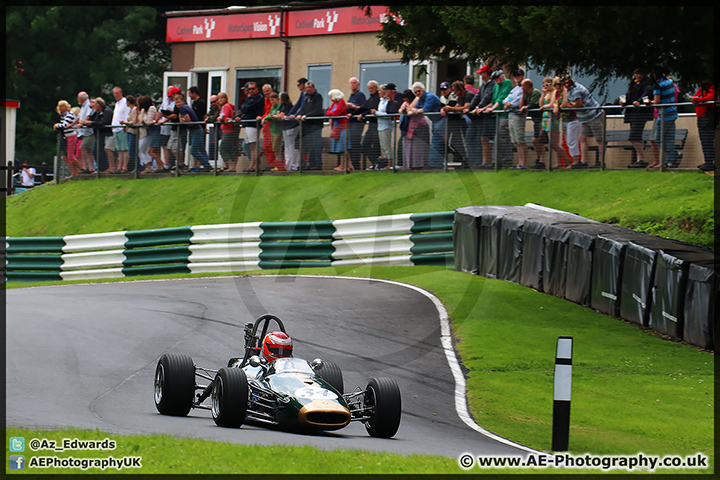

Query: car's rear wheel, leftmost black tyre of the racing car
[155,353,195,417]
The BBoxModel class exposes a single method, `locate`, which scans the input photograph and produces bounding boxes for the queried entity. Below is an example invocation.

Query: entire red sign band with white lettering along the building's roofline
[166,6,396,43]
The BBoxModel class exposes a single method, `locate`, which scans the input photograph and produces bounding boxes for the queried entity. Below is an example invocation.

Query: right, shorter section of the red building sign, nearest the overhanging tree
[285,6,388,37]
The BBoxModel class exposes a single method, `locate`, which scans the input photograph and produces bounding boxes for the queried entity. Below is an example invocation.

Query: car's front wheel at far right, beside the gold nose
[365,377,402,438]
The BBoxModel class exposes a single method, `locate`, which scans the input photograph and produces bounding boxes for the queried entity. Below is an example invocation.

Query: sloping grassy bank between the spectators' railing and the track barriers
[6,171,714,246]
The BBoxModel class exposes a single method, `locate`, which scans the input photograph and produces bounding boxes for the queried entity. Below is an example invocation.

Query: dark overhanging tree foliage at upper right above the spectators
[378,5,714,88]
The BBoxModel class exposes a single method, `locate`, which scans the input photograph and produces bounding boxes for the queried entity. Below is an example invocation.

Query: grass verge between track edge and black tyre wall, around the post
[5,267,714,473]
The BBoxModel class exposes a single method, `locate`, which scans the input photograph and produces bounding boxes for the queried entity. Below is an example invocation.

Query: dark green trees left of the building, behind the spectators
[5,6,170,163]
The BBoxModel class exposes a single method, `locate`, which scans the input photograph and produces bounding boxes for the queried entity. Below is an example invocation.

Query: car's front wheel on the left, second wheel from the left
[210,368,248,428]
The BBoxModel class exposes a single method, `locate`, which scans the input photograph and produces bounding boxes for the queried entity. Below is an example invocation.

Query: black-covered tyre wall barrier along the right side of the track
[453,204,720,349]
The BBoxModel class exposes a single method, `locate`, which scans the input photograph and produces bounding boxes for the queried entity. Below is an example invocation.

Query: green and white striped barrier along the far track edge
[4,211,453,281]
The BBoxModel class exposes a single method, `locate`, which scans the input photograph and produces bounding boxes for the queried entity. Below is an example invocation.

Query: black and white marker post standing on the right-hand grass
[552,337,572,452]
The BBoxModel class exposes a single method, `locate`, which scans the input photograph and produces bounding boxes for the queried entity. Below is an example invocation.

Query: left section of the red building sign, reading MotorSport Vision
[166,12,281,42]
